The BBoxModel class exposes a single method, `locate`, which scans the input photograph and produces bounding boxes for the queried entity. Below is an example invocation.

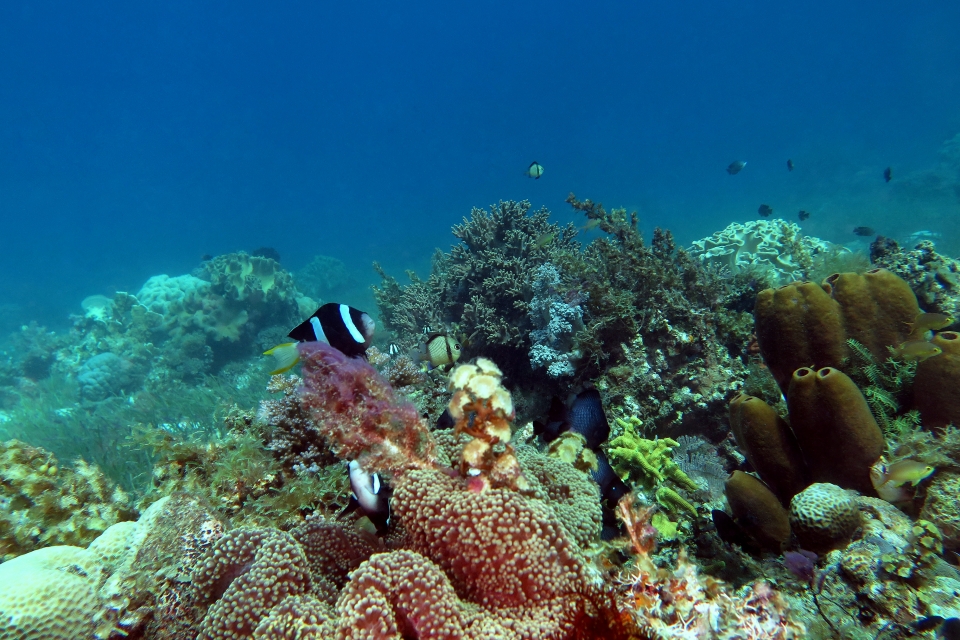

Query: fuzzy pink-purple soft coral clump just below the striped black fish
[298,342,434,474]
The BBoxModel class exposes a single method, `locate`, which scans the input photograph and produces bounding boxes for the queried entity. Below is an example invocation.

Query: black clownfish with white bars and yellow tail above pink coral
[263,302,377,375]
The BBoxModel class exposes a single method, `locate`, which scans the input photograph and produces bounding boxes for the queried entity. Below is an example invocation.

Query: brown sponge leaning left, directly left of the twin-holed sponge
[730,393,809,504]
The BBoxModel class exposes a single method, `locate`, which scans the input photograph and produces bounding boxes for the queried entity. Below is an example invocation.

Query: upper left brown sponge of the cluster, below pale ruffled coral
[754,282,847,393]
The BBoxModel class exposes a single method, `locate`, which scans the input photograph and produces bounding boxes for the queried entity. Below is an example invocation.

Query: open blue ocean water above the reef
[0,0,960,333]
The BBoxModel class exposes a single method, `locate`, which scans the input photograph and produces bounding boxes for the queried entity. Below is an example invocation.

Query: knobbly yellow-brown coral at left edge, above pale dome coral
[0,440,137,560]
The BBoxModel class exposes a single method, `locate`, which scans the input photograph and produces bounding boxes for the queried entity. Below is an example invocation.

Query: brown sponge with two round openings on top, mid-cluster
[787,367,884,496]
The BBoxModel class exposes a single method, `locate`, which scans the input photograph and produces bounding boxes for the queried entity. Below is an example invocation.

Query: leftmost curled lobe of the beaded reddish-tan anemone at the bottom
[192,529,310,640]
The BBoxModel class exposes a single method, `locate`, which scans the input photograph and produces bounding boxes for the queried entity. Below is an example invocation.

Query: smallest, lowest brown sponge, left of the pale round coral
[726,471,790,552]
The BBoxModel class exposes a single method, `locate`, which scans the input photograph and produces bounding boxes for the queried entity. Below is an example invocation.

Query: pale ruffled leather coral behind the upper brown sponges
[690,218,832,282]
